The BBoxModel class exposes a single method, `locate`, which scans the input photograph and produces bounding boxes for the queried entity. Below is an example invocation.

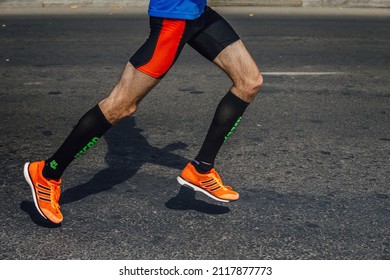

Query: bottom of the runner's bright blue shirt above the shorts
[148,0,207,19]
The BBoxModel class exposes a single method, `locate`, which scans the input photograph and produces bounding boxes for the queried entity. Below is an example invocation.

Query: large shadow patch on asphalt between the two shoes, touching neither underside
[60,117,188,204]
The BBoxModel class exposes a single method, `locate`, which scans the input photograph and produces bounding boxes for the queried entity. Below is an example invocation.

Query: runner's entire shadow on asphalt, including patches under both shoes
[20,117,230,228]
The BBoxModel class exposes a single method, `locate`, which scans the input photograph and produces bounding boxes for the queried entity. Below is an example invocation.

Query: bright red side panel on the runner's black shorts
[137,19,186,78]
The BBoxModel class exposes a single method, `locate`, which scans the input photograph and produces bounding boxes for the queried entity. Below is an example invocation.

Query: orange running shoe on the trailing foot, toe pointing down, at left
[24,161,63,224]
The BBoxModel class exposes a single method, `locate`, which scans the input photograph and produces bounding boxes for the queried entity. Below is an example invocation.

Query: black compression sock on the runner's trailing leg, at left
[43,105,112,180]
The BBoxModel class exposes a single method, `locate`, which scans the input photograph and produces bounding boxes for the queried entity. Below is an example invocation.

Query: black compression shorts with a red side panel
[130,7,240,79]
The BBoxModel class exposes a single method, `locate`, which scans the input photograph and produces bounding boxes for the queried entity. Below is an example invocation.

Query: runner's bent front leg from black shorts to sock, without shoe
[189,8,262,173]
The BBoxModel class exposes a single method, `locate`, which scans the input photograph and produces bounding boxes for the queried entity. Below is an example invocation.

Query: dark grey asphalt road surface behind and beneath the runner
[0,8,390,260]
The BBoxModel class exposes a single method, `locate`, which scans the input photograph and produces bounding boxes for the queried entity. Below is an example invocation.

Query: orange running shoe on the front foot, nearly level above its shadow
[177,163,240,202]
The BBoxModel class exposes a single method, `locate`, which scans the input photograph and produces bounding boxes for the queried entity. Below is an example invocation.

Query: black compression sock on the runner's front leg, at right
[194,91,249,172]
